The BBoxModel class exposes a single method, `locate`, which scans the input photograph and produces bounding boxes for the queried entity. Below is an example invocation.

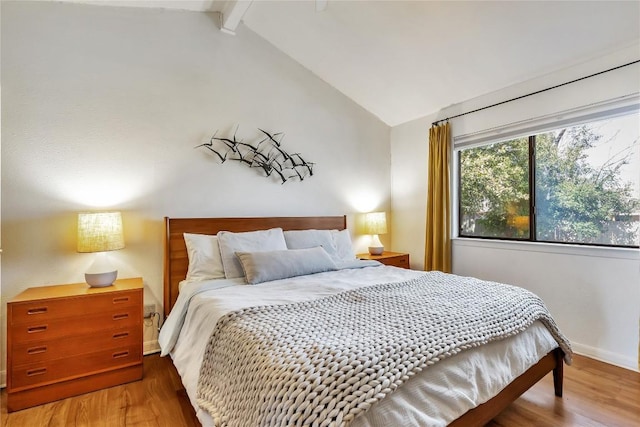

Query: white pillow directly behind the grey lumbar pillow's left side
[218,228,287,279]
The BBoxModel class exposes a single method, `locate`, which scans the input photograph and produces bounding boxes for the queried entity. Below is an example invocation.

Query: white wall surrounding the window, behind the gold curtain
[391,45,640,369]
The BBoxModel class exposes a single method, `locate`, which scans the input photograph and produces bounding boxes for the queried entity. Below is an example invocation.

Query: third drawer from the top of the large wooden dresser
[11,325,142,366]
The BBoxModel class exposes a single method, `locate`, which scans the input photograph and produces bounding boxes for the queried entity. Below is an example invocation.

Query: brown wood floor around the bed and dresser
[0,355,640,427]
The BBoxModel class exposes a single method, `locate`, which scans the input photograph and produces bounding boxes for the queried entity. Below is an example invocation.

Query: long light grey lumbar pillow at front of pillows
[236,246,336,285]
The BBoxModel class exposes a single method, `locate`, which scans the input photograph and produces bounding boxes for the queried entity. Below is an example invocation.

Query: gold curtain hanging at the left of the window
[424,122,451,273]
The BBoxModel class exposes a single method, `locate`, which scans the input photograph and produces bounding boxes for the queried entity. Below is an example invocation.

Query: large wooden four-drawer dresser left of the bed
[7,278,143,412]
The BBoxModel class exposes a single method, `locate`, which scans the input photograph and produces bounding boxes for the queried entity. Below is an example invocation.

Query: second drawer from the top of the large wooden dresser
[10,306,142,345]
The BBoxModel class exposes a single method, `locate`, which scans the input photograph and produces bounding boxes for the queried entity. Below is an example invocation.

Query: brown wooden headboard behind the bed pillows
[164,215,347,316]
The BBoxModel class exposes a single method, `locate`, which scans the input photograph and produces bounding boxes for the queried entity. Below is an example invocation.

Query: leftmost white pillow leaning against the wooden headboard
[184,233,224,281]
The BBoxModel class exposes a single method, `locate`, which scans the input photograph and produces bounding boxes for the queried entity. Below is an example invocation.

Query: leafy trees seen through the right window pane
[536,125,640,246]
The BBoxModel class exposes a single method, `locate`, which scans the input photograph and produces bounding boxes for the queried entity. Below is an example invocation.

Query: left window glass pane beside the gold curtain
[459,138,529,239]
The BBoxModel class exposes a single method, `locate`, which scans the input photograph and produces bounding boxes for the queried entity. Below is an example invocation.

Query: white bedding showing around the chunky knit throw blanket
[159,266,557,427]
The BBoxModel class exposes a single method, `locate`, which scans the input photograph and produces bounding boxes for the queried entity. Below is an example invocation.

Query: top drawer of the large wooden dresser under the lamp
[9,291,142,325]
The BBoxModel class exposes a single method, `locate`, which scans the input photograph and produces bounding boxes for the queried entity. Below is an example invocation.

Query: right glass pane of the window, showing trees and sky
[535,113,640,246]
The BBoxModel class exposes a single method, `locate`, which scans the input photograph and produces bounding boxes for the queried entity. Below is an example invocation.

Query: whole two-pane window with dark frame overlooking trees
[458,111,640,247]
